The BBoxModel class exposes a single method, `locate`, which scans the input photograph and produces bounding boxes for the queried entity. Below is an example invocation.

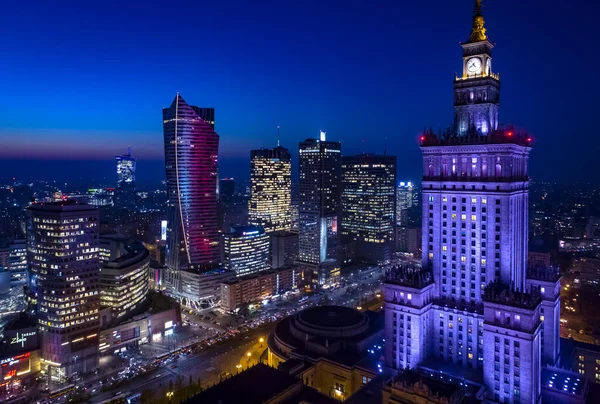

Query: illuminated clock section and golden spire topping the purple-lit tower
[454,0,500,136]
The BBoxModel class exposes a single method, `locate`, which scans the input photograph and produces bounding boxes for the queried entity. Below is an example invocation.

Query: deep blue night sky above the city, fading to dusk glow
[0,0,600,182]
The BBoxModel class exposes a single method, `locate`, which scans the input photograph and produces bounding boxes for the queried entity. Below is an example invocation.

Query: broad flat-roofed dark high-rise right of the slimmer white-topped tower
[341,154,396,264]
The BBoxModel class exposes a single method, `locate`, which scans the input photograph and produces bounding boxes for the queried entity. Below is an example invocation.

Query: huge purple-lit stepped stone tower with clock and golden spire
[384,0,560,403]
